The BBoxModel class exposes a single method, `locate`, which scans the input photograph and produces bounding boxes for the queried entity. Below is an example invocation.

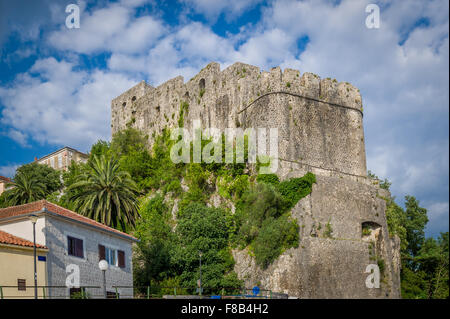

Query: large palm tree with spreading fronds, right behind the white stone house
[68,155,139,230]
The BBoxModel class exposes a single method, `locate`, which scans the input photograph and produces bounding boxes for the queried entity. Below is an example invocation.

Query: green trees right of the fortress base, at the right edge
[369,171,449,299]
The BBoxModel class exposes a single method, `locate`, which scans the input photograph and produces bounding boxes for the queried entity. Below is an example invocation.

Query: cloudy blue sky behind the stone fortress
[0,0,449,236]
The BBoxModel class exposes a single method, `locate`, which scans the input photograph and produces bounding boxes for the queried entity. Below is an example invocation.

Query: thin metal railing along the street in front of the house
[0,286,288,299]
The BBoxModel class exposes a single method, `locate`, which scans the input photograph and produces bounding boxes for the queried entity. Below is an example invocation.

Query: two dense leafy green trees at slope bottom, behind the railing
[135,199,242,294]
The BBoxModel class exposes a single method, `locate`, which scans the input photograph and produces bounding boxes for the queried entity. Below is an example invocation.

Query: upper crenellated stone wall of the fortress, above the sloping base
[111,62,366,177]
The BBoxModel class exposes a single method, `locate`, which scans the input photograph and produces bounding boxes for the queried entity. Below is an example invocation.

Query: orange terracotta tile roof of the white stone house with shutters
[0,200,137,241]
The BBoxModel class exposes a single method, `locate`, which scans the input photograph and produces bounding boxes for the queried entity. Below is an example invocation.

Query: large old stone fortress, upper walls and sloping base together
[111,63,400,298]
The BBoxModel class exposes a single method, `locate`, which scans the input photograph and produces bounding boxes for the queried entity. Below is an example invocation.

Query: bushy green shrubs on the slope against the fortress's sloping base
[235,173,315,268]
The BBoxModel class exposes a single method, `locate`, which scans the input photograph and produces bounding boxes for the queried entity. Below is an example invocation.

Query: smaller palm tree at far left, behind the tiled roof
[5,173,46,206]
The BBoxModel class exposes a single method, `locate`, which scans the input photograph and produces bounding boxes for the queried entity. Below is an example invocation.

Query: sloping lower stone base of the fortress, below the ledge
[233,171,400,298]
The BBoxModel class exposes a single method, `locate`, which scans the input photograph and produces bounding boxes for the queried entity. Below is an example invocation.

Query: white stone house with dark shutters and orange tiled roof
[0,200,138,298]
